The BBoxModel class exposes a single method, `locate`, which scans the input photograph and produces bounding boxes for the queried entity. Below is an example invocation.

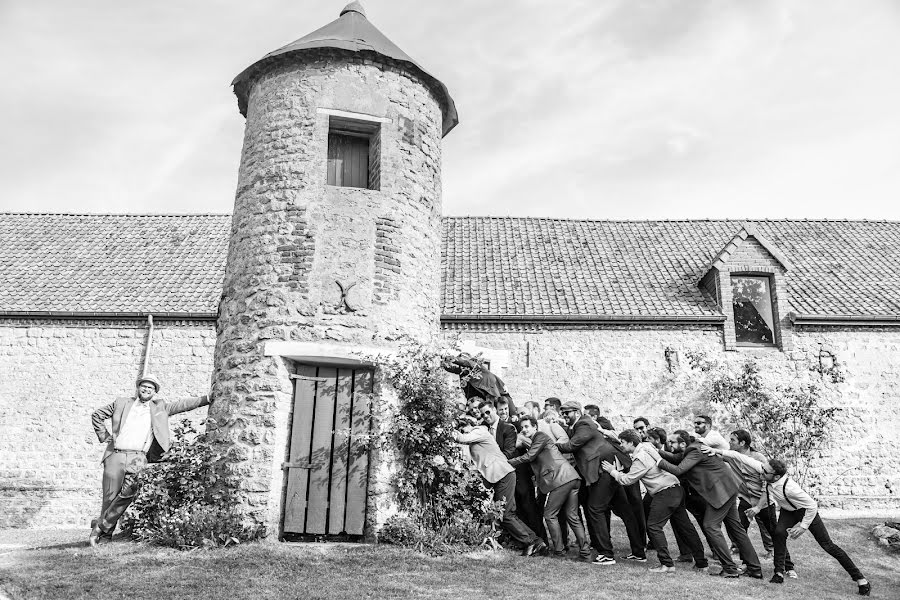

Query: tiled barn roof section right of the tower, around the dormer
[441,217,900,318]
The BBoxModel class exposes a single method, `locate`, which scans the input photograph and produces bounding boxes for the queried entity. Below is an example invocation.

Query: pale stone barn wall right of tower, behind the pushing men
[445,326,900,509]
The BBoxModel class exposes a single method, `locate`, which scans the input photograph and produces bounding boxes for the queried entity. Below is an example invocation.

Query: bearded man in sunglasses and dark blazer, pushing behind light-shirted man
[658,430,762,579]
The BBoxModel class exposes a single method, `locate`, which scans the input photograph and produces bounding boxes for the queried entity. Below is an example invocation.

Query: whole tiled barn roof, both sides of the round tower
[0,214,900,319]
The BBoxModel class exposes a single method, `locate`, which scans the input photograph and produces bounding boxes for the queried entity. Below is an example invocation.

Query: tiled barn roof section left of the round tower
[0,214,231,314]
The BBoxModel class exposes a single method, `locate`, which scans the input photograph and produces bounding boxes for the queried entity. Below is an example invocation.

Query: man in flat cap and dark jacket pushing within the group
[556,401,647,565]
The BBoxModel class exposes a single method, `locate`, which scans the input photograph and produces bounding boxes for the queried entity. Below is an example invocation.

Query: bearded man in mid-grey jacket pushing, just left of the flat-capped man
[509,417,591,561]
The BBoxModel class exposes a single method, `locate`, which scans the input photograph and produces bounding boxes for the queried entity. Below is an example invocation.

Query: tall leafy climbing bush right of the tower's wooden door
[379,342,502,553]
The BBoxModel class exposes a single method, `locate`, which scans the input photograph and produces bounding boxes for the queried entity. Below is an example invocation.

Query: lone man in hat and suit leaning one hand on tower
[88,375,209,546]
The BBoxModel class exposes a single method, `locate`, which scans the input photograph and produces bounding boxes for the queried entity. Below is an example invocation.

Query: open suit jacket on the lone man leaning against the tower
[91,396,209,462]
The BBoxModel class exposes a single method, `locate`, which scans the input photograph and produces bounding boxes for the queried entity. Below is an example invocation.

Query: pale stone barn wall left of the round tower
[0,319,215,527]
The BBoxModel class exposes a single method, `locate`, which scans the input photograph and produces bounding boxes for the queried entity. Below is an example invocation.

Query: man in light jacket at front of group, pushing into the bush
[453,415,547,556]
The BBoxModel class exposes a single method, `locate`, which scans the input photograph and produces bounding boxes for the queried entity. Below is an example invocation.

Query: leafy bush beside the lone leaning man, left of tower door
[121,421,263,549]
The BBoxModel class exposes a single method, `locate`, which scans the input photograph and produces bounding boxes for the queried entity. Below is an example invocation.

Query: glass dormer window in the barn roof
[731,273,776,346]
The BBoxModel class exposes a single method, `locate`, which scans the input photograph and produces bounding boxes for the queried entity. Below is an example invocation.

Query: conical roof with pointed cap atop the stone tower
[231,1,459,135]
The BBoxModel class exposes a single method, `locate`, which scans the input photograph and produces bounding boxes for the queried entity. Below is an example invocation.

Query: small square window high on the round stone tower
[326,115,381,190]
